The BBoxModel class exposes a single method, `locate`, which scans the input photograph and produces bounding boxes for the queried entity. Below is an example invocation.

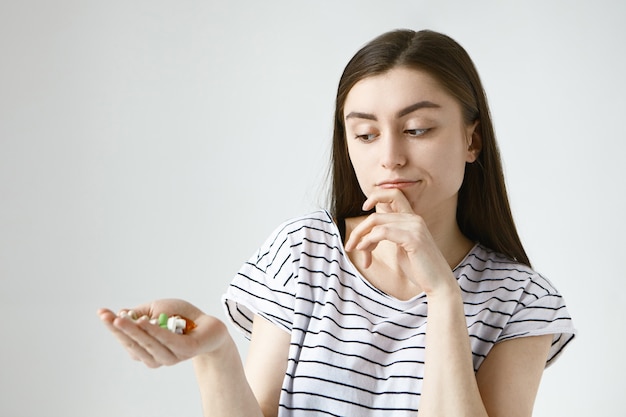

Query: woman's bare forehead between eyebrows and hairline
[344,67,457,116]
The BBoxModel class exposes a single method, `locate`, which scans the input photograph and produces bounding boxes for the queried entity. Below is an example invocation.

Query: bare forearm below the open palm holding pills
[193,322,263,417]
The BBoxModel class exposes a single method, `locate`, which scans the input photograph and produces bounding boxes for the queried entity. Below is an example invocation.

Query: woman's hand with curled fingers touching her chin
[345,189,458,295]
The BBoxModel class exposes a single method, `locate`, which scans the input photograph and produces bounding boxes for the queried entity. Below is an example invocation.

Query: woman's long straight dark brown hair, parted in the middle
[330,30,530,266]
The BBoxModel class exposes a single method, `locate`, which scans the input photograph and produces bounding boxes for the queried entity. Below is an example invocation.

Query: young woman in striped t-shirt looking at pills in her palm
[99,30,574,417]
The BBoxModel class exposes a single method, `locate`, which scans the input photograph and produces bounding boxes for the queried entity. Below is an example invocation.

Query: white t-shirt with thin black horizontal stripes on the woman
[224,211,574,417]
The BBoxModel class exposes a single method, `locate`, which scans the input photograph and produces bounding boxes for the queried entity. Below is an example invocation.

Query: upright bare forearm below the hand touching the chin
[419,288,487,417]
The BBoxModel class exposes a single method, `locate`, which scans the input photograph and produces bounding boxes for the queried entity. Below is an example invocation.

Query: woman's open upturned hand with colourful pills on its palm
[98,299,229,368]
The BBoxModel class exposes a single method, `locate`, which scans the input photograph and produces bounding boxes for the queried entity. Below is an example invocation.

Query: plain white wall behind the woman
[0,0,626,417]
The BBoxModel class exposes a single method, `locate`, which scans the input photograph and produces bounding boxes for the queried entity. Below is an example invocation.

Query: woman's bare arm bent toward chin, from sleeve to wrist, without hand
[420,286,551,417]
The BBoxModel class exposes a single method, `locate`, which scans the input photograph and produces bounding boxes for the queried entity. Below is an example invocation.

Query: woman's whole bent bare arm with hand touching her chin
[345,190,550,417]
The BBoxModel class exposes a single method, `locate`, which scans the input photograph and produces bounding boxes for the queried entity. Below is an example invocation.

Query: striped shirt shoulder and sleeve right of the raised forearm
[455,245,576,364]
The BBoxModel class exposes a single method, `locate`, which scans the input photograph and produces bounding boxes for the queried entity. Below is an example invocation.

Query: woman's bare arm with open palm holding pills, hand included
[98,300,289,417]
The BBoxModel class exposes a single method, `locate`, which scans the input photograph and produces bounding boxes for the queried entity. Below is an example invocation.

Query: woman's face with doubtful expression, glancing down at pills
[343,67,480,220]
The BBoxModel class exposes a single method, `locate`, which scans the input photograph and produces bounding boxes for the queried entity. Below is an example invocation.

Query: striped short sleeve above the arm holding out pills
[222,221,296,339]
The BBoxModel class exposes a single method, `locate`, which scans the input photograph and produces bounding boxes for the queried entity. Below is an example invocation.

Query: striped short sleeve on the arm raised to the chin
[498,275,576,367]
